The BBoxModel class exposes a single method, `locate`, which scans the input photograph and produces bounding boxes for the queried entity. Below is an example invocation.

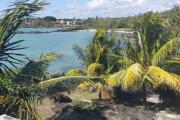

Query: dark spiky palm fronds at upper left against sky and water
[0,0,46,73]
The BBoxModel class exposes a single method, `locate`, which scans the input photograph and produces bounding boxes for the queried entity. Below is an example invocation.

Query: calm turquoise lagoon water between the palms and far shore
[13,28,95,73]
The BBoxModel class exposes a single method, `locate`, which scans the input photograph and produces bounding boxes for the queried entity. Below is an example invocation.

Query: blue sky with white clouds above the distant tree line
[0,0,180,18]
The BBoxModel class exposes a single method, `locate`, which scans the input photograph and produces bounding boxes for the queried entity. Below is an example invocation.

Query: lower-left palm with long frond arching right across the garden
[0,53,104,120]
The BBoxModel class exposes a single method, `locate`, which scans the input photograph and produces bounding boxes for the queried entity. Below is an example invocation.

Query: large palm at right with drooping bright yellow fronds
[109,13,180,102]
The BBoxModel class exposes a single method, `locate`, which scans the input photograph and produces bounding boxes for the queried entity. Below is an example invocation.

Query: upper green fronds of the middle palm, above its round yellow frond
[73,29,117,70]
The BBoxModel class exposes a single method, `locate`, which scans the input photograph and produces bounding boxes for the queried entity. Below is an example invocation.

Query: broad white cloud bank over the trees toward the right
[60,0,180,18]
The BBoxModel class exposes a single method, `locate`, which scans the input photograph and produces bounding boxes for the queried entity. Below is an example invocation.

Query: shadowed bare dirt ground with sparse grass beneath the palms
[37,93,180,120]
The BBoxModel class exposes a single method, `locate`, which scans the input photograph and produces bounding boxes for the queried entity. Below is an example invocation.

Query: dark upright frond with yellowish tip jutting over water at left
[14,52,62,84]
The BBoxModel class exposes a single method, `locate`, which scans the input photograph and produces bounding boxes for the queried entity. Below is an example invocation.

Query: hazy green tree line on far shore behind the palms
[82,6,180,33]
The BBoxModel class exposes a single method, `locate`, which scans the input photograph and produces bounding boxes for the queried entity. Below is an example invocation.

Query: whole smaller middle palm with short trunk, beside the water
[73,29,122,99]
